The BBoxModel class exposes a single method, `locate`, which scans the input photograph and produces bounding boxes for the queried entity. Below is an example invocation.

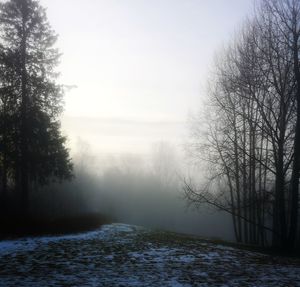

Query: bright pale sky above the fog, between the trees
[40,0,253,158]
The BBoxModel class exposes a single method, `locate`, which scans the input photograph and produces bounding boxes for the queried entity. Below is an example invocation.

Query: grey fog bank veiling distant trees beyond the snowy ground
[31,140,234,240]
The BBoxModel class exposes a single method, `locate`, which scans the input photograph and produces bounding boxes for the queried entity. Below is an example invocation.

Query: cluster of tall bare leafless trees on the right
[185,0,300,252]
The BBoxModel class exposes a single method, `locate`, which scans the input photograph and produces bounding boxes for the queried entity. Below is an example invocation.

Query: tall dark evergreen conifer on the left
[0,0,72,215]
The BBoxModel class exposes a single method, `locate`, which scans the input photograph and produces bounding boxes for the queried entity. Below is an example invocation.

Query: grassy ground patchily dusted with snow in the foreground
[0,224,300,287]
